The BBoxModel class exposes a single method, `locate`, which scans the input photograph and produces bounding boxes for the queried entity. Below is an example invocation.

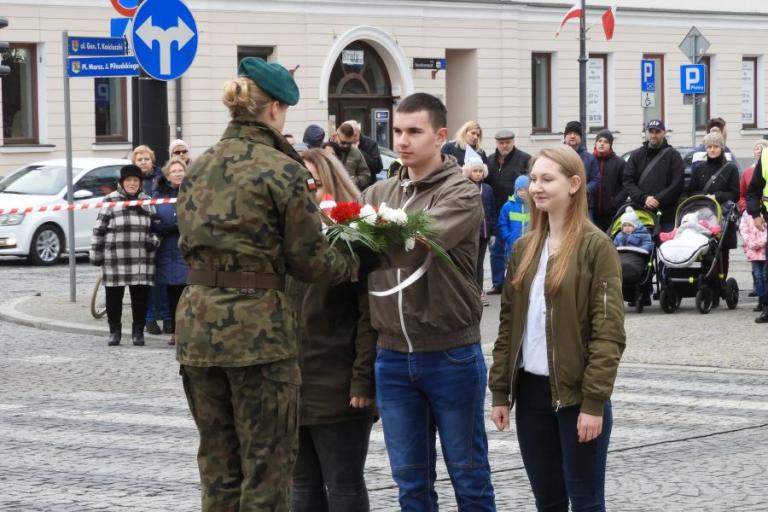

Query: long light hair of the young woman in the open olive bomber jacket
[512,145,589,295]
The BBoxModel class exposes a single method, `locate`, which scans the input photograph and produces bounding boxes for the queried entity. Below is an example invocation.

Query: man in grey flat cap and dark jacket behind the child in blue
[485,129,531,295]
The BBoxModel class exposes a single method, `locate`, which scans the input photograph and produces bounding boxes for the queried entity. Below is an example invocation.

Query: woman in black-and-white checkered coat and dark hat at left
[89,165,159,346]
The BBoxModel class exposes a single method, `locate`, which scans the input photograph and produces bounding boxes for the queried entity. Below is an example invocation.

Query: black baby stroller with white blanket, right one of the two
[657,195,739,314]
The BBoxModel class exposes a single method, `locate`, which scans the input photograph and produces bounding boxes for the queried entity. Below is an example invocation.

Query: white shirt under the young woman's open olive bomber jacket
[520,237,549,376]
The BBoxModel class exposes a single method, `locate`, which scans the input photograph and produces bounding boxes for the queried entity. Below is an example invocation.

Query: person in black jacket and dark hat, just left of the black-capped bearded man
[593,130,627,231]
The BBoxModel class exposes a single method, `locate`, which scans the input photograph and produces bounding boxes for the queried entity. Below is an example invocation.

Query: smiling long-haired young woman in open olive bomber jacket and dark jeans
[489,146,625,512]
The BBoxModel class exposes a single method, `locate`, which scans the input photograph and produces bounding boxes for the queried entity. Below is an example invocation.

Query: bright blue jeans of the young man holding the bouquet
[375,343,496,512]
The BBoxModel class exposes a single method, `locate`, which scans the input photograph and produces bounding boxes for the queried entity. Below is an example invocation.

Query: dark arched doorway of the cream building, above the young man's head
[328,41,394,147]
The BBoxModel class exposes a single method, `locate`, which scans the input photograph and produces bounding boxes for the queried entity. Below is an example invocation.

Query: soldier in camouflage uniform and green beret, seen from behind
[176,57,358,512]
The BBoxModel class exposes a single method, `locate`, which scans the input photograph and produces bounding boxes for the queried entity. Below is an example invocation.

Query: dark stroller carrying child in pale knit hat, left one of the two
[608,205,659,313]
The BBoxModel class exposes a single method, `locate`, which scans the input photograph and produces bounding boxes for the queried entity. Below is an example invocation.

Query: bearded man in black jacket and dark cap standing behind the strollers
[624,119,685,231]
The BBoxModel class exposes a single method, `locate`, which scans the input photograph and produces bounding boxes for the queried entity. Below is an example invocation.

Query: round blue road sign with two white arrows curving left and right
[132,0,198,80]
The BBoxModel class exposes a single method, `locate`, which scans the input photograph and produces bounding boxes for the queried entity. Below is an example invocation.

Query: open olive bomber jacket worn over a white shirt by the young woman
[488,224,625,416]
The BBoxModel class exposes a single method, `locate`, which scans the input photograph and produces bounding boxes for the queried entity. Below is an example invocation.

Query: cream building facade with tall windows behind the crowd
[0,0,768,176]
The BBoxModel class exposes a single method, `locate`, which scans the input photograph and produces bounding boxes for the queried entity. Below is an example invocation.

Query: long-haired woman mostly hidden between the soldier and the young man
[287,149,376,512]
